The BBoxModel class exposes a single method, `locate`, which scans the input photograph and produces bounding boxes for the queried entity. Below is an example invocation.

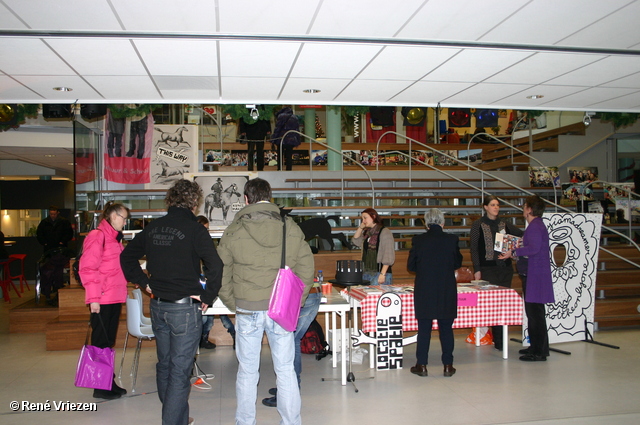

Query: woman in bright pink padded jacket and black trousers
[79,202,129,400]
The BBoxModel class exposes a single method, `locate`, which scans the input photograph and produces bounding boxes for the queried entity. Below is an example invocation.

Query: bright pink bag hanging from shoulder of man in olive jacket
[267,217,305,332]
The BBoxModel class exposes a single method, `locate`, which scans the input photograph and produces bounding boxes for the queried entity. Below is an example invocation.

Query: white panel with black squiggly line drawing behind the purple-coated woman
[522,213,602,345]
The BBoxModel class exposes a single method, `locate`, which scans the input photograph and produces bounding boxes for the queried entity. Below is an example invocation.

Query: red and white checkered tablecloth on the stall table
[350,287,523,332]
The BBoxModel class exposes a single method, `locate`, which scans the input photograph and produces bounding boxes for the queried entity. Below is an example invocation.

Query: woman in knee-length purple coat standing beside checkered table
[500,196,555,362]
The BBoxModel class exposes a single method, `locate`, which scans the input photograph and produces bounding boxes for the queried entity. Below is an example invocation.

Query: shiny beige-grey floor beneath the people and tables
[0,286,640,425]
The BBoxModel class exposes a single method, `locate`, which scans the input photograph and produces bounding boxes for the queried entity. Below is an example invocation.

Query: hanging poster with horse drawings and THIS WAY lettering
[147,125,198,189]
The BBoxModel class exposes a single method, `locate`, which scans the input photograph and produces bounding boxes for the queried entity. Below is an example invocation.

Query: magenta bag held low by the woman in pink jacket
[75,315,116,391]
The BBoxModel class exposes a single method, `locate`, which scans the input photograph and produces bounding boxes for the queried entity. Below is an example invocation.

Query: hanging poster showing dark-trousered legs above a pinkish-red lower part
[103,111,153,184]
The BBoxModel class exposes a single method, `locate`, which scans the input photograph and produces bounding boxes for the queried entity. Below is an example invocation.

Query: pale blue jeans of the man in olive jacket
[236,308,302,425]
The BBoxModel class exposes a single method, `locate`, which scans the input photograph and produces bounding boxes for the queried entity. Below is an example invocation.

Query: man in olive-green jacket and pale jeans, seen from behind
[218,178,314,425]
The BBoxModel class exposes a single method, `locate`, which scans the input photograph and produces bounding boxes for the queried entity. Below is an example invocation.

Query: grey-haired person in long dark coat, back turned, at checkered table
[407,208,462,376]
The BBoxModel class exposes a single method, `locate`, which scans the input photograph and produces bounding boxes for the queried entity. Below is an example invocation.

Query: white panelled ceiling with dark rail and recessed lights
[0,0,640,112]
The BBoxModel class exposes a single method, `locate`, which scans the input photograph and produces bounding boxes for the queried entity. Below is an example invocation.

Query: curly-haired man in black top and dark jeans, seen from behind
[120,179,222,425]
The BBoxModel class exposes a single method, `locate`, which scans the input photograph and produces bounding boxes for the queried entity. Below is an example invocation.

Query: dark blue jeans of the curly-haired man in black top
[150,299,202,425]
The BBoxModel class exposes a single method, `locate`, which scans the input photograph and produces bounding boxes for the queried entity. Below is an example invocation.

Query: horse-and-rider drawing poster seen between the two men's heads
[185,172,257,230]
